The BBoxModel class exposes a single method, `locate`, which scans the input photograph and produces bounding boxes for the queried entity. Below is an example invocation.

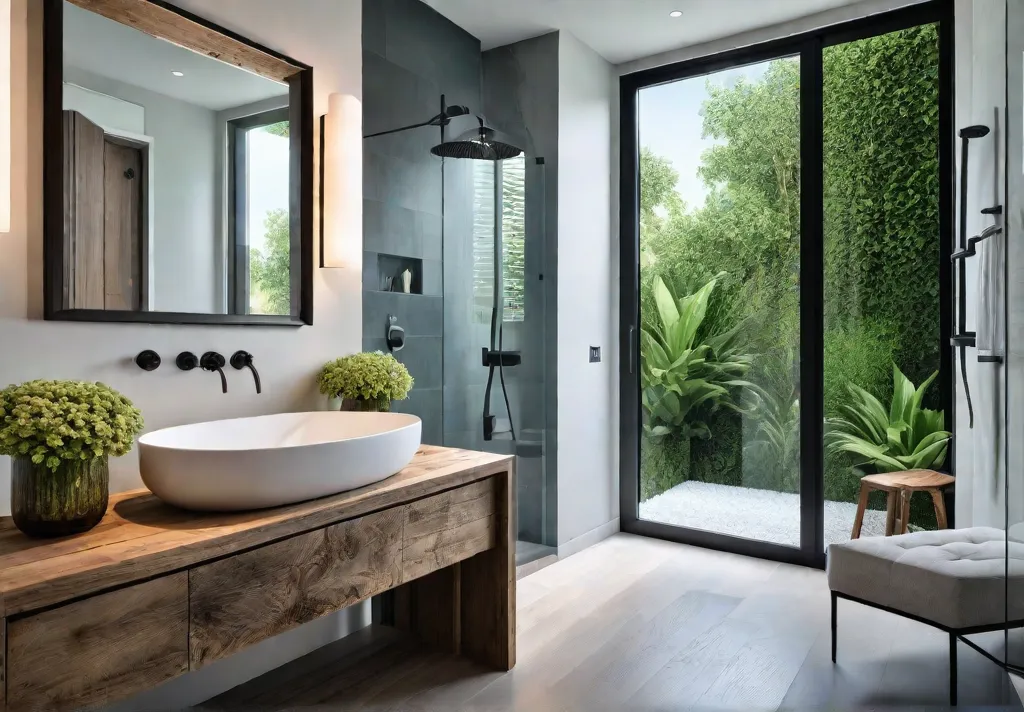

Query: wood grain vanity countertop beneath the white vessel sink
[0,446,513,617]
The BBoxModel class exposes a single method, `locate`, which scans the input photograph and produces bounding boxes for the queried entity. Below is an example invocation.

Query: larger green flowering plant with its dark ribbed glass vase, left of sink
[0,381,142,537]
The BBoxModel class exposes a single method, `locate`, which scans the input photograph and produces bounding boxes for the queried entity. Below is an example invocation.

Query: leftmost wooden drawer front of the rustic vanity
[7,572,188,712]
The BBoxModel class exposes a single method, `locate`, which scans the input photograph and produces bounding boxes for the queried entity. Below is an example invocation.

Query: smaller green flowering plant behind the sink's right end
[316,351,413,413]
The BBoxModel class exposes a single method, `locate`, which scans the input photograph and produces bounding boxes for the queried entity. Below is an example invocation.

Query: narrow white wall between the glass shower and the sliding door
[558,31,618,547]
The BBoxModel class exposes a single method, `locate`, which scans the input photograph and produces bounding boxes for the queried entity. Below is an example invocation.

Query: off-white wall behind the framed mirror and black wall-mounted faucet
[0,0,364,709]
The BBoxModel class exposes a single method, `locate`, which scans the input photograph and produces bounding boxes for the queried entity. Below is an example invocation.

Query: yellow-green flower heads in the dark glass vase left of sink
[0,380,142,471]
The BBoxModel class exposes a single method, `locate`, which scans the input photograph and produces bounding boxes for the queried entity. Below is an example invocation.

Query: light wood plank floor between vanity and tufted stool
[195,535,1020,712]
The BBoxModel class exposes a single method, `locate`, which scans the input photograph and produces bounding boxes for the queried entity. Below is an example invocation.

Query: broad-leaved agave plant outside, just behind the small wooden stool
[825,364,951,471]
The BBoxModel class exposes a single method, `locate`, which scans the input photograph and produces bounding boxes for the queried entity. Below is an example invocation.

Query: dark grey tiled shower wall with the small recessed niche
[362,0,480,445]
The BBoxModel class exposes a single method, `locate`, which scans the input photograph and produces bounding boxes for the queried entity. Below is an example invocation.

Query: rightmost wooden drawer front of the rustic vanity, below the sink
[401,477,499,581]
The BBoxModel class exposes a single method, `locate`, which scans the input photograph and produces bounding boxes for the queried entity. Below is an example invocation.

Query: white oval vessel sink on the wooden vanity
[138,412,421,511]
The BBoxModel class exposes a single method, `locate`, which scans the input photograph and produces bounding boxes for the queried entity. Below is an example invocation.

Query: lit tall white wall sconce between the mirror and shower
[319,94,362,270]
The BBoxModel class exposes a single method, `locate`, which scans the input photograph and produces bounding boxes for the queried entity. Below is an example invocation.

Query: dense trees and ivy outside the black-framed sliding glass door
[640,26,948,520]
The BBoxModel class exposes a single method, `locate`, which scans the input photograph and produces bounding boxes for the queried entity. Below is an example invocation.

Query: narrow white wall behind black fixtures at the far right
[954,0,1006,527]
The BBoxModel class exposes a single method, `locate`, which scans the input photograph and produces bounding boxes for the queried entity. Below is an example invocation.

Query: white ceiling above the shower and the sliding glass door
[424,0,872,65]
